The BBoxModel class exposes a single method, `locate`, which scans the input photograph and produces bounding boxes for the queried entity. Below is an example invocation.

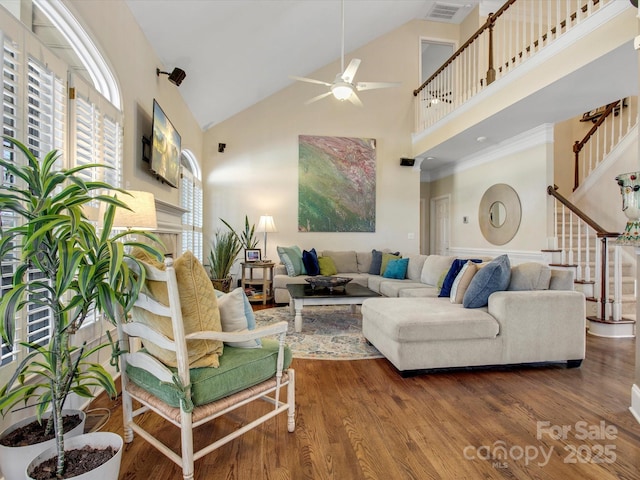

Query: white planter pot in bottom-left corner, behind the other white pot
[0,410,87,480]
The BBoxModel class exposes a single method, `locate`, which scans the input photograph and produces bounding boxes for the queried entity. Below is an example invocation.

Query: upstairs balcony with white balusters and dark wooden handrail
[413,0,638,172]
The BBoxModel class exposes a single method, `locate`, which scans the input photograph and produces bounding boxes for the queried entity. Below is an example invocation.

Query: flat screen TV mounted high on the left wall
[149,99,182,188]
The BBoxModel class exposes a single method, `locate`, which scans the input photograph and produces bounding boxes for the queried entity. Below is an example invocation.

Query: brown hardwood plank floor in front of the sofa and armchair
[93,336,640,480]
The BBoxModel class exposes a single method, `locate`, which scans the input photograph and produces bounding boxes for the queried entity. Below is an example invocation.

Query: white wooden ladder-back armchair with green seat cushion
[118,259,295,480]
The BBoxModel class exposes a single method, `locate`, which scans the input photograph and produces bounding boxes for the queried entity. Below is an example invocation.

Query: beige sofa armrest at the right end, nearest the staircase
[488,290,586,363]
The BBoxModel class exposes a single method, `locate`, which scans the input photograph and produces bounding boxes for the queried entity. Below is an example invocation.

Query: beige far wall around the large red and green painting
[203,21,457,259]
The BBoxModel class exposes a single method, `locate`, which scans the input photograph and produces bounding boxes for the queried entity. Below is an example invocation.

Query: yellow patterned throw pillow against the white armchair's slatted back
[132,251,224,368]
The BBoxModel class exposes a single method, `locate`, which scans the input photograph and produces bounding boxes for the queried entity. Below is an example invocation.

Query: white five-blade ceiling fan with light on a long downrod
[289,0,400,107]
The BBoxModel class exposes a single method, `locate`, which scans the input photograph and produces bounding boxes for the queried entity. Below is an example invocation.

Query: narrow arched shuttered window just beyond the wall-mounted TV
[180,150,203,262]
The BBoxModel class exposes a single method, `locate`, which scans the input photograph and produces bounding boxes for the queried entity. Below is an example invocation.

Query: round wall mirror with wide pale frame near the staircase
[478,183,522,245]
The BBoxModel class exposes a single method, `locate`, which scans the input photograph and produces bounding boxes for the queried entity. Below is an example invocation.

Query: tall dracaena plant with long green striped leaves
[0,137,162,474]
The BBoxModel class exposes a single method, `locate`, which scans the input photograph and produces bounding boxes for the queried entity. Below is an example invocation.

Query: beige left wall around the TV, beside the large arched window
[65,0,202,205]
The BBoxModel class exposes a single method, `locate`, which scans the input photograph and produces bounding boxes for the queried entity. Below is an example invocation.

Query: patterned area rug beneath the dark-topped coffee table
[255,305,382,360]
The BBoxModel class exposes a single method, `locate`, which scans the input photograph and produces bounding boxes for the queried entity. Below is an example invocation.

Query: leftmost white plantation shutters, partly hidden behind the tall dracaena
[0,17,67,365]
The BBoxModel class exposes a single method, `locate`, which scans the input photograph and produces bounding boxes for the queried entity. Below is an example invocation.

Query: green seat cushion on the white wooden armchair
[127,339,292,408]
